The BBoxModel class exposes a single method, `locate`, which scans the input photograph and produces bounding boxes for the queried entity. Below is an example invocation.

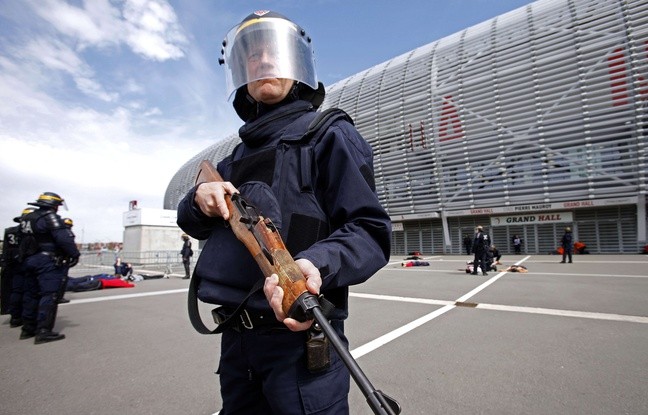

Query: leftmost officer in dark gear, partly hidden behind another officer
[2,208,34,327]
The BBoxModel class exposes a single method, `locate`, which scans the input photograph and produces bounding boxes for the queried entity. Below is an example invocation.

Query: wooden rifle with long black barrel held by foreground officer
[196,160,401,415]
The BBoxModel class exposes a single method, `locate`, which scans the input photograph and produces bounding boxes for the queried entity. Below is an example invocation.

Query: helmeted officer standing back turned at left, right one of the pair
[20,192,80,344]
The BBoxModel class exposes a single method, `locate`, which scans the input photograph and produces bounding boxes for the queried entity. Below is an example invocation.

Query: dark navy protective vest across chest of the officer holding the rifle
[226,108,353,255]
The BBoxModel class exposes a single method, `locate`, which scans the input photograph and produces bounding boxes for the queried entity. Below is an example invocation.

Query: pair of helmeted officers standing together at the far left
[2,192,80,344]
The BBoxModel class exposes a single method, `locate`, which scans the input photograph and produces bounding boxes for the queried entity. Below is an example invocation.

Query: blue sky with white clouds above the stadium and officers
[0,0,531,243]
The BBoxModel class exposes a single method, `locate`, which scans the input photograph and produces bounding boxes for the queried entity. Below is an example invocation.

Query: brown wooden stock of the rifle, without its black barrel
[196,160,308,321]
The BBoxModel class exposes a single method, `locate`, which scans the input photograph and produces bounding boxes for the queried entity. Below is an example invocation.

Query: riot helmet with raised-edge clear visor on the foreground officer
[219,10,325,121]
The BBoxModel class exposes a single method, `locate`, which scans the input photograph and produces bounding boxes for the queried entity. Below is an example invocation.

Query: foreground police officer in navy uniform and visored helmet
[178,11,391,415]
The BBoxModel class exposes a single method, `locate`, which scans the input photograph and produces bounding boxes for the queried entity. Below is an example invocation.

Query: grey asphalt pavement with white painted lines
[0,255,648,415]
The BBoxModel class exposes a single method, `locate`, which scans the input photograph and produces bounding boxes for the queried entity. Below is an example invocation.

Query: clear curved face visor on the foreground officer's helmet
[223,17,318,100]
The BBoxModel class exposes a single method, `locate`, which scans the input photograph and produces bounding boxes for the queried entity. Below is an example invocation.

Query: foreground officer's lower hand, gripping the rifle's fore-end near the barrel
[263,259,322,331]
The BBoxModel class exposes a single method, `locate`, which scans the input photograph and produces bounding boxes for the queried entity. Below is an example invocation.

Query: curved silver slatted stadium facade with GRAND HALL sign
[164,0,648,254]
